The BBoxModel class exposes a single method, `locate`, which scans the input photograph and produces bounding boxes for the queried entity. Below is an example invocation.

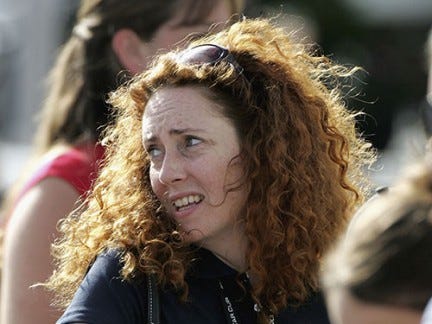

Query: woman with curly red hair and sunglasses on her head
[48,19,373,323]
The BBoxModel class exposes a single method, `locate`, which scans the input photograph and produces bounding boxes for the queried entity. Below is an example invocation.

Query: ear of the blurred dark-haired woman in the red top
[111,28,148,74]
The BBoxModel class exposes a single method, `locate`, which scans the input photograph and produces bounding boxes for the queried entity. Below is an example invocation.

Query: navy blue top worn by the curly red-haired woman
[57,249,329,324]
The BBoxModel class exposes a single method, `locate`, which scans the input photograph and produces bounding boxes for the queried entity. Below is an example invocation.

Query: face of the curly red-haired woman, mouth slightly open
[142,86,247,250]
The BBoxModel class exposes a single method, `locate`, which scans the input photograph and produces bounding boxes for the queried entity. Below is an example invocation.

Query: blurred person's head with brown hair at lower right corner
[321,157,432,324]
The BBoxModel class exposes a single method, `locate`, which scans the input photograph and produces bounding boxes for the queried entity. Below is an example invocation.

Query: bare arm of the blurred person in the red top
[0,178,79,324]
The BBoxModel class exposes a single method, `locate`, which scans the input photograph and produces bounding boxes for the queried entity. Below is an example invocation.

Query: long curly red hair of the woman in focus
[48,19,374,313]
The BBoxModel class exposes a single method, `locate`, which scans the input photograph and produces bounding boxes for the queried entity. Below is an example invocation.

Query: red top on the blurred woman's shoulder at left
[18,144,104,200]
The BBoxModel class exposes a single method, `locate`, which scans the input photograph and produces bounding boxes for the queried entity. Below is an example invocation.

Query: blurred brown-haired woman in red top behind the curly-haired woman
[1,0,244,324]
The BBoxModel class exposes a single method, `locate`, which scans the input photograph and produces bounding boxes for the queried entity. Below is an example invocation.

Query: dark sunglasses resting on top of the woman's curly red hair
[179,44,243,75]
